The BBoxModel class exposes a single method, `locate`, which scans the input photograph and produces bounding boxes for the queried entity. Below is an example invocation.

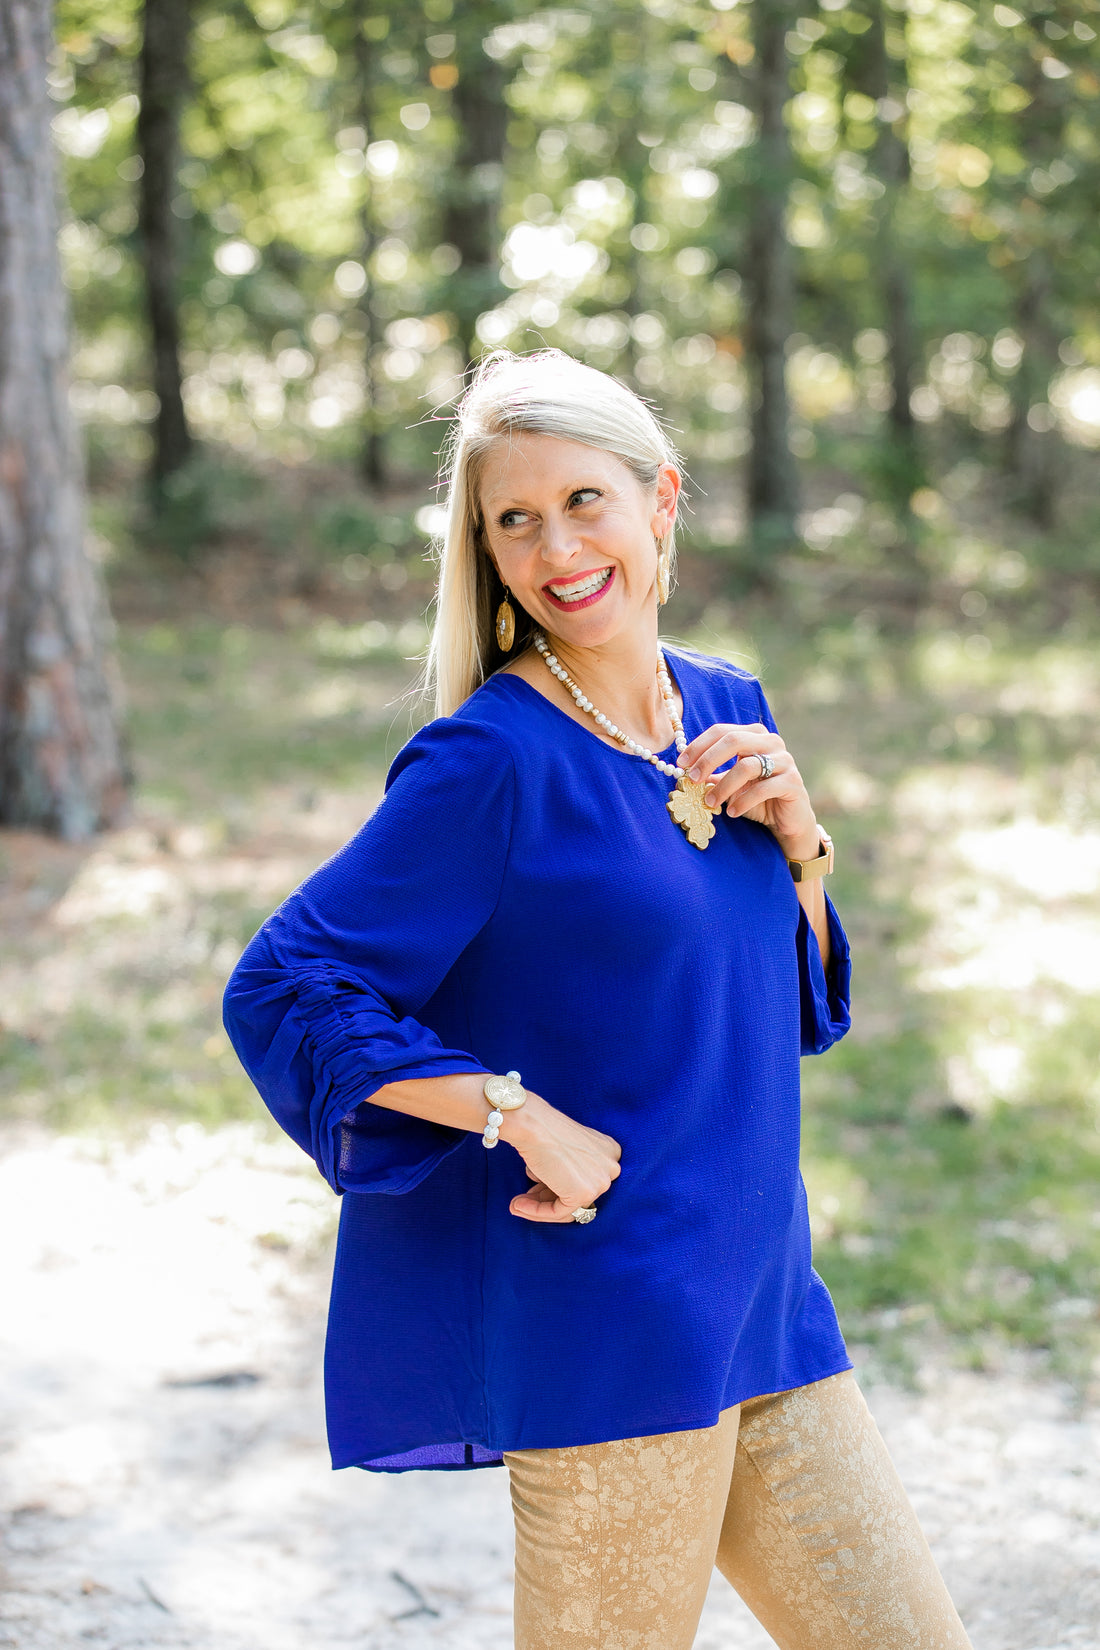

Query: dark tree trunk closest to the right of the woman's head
[745,0,798,545]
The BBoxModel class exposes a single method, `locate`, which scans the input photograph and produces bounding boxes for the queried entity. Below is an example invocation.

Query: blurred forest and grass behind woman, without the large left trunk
[0,0,1100,1396]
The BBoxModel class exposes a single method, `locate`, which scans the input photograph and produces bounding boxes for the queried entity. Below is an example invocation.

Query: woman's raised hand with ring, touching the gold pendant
[678,723,820,860]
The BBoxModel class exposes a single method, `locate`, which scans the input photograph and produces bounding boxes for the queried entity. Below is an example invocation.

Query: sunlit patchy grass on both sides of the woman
[0,508,1100,1388]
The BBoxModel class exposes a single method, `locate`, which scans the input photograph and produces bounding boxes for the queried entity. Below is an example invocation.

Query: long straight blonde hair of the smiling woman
[425,350,679,716]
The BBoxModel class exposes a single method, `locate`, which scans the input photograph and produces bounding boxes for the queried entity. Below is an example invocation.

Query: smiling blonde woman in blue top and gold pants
[226,351,966,1650]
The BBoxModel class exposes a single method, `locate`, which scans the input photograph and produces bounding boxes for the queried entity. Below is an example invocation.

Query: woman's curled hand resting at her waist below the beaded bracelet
[500,1089,622,1224]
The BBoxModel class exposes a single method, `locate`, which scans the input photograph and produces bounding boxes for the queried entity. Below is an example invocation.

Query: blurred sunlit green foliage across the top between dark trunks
[51,0,1100,536]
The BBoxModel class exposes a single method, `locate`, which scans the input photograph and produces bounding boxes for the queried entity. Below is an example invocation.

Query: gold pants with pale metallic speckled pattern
[505,1374,970,1650]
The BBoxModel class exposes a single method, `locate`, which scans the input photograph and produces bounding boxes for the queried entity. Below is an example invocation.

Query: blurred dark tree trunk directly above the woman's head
[444,3,511,361]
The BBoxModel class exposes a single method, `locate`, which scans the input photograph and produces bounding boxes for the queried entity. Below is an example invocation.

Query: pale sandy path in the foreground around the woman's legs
[0,1127,1100,1650]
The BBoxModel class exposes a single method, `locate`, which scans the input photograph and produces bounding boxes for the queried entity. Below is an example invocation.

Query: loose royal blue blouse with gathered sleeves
[224,648,851,1472]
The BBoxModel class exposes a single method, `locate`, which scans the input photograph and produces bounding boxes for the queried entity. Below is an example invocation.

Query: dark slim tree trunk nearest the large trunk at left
[137,0,193,490]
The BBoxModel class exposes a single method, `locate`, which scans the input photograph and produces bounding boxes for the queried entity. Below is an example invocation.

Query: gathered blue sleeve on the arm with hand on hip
[224,718,516,1193]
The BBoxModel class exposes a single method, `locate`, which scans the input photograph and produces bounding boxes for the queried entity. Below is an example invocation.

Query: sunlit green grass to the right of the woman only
[694,592,1100,1389]
